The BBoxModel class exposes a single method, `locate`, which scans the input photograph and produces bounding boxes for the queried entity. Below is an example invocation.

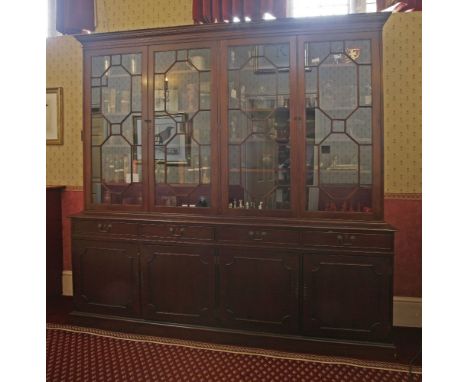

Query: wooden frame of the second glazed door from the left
[146,40,220,215]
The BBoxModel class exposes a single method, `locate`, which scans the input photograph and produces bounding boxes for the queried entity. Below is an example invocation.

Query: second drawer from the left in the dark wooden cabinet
[140,224,214,241]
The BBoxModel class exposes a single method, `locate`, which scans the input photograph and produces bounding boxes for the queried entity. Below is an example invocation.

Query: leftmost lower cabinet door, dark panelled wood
[73,240,140,316]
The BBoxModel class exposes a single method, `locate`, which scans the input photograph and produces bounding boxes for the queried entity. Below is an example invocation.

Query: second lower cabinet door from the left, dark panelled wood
[142,245,215,324]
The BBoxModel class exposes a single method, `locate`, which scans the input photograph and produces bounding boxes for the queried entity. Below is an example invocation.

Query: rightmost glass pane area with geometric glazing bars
[304,40,372,213]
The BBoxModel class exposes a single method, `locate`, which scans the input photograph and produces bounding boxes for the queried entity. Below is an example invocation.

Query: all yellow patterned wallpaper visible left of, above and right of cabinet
[47,9,422,193]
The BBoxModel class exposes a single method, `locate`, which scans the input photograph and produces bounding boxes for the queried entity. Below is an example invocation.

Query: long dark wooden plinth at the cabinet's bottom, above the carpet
[70,311,396,361]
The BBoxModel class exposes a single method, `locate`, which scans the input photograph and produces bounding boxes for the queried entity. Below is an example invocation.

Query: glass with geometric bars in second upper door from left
[153,49,211,207]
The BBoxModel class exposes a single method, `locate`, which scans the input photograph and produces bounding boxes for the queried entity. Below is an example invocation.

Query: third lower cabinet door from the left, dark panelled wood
[220,248,299,333]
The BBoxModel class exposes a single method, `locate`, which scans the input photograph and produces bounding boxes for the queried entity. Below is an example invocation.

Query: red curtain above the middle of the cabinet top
[192,0,286,24]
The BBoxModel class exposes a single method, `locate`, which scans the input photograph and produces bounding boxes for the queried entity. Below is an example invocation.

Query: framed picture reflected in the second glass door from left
[154,113,191,166]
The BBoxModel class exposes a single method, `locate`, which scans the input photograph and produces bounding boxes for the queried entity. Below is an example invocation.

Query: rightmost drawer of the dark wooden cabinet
[302,230,393,250]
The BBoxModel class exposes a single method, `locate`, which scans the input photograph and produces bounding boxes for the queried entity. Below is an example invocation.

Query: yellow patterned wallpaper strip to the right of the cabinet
[383,12,422,193]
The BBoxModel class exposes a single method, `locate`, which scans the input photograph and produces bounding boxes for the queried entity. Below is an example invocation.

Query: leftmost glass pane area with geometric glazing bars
[91,54,143,205]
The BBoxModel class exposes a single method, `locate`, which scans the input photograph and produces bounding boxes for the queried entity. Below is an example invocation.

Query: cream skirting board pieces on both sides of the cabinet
[62,271,422,328]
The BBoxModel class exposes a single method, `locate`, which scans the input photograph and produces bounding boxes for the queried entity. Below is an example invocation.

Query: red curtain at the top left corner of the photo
[56,0,94,34]
